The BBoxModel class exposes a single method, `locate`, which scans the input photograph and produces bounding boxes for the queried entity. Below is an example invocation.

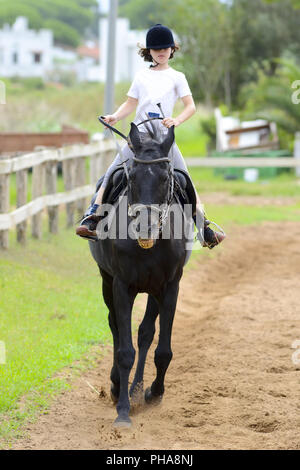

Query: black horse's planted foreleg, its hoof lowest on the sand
[113,278,136,427]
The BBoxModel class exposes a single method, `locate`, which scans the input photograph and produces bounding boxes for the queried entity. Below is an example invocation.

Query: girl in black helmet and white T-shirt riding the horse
[76,24,225,248]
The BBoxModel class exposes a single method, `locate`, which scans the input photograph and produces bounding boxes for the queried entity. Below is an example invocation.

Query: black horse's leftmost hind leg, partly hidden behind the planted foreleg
[100,269,120,403]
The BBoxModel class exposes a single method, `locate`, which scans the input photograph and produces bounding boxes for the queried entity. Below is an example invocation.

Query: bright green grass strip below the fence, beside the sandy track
[0,213,111,444]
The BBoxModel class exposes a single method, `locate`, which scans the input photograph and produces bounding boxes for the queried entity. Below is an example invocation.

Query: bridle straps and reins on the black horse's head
[98,114,174,234]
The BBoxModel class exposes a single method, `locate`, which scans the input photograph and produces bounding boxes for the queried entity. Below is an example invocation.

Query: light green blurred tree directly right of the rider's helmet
[165,0,231,106]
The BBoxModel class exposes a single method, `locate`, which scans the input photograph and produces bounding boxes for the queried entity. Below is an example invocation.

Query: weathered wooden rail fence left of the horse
[0,140,116,249]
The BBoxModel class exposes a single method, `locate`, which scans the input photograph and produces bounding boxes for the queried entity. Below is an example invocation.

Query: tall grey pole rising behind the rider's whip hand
[104,0,118,114]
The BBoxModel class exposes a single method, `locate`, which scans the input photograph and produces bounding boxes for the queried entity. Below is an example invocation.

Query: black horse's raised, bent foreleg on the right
[145,281,179,403]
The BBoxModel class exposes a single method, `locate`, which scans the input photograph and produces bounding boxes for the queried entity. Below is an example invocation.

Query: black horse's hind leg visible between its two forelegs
[129,295,158,401]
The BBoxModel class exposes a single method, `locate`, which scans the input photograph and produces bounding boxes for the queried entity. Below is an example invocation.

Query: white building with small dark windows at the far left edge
[0,17,53,78]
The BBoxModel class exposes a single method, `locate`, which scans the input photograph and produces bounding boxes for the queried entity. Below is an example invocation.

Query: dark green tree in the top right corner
[226,0,300,102]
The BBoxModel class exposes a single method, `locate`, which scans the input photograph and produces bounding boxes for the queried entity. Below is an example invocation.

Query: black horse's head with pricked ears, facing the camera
[128,123,174,246]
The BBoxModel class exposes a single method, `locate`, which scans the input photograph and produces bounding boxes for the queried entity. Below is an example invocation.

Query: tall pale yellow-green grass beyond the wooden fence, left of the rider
[0,80,129,133]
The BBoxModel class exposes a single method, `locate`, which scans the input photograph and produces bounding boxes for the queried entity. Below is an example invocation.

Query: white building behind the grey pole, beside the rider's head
[99,18,146,83]
